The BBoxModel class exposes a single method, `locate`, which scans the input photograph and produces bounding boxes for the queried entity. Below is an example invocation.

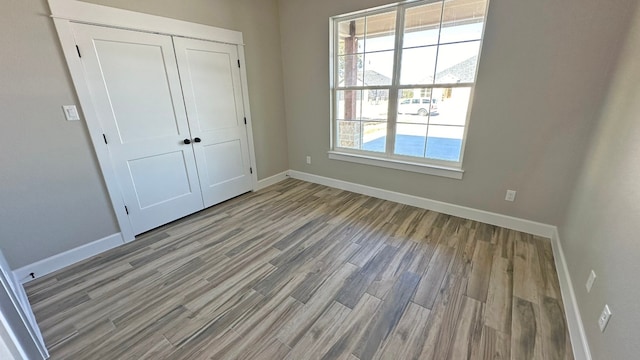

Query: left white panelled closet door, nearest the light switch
[73,24,203,234]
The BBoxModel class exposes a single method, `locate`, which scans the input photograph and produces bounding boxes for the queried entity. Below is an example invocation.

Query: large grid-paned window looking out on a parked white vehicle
[331,0,487,176]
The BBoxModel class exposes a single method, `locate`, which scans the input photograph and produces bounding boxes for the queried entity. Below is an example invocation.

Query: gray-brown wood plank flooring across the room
[26,179,573,360]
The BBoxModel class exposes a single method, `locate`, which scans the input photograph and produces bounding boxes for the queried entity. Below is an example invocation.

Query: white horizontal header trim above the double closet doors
[49,0,243,45]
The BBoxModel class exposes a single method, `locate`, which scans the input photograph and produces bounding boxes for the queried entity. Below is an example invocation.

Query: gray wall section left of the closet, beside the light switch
[0,0,119,269]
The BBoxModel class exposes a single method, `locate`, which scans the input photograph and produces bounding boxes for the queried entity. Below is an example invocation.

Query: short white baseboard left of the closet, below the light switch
[13,233,125,284]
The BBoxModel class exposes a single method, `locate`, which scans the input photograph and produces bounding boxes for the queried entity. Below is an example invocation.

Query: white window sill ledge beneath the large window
[329,151,464,180]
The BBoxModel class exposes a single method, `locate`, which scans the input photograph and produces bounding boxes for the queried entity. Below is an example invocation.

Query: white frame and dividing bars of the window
[328,0,489,179]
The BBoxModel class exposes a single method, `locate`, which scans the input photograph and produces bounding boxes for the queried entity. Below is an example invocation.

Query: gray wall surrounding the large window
[279,0,629,224]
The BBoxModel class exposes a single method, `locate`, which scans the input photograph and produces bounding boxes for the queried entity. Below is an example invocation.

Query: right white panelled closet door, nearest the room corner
[174,38,251,207]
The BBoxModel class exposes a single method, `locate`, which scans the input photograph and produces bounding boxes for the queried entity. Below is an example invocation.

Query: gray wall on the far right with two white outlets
[560,2,640,359]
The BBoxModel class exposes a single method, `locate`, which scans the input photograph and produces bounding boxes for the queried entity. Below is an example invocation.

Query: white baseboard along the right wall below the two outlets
[551,228,591,360]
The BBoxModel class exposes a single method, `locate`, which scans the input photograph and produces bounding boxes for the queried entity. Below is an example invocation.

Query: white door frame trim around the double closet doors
[48,0,258,242]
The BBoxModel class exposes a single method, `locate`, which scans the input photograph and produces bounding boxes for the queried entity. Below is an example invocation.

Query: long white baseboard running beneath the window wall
[289,170,555,238]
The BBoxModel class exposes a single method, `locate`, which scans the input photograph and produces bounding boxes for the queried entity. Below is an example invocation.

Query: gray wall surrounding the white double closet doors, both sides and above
[0,0,289,269]
